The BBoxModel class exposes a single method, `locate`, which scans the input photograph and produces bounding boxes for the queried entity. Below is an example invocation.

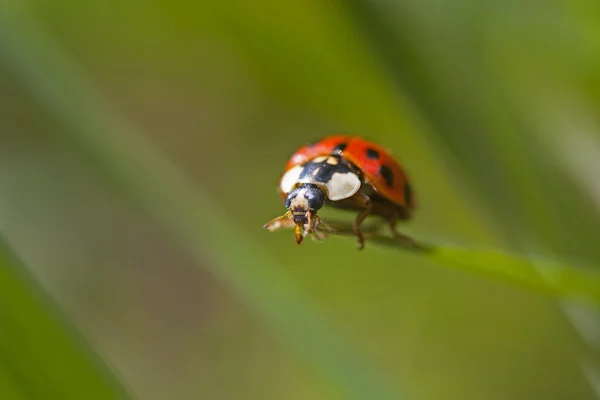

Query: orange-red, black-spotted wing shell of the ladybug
[285,135,415,208]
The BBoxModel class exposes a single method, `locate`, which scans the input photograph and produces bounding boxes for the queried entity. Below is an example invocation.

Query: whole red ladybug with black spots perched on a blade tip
[264,135,415,249]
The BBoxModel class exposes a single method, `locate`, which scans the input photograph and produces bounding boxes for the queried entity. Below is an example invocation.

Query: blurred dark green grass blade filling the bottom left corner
[0,238,129,400]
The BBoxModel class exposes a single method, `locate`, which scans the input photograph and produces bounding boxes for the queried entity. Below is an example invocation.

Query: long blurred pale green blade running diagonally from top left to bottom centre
[0,5,402,399]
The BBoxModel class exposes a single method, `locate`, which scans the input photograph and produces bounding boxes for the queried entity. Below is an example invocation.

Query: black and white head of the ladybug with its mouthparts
[285,184,325,244]
